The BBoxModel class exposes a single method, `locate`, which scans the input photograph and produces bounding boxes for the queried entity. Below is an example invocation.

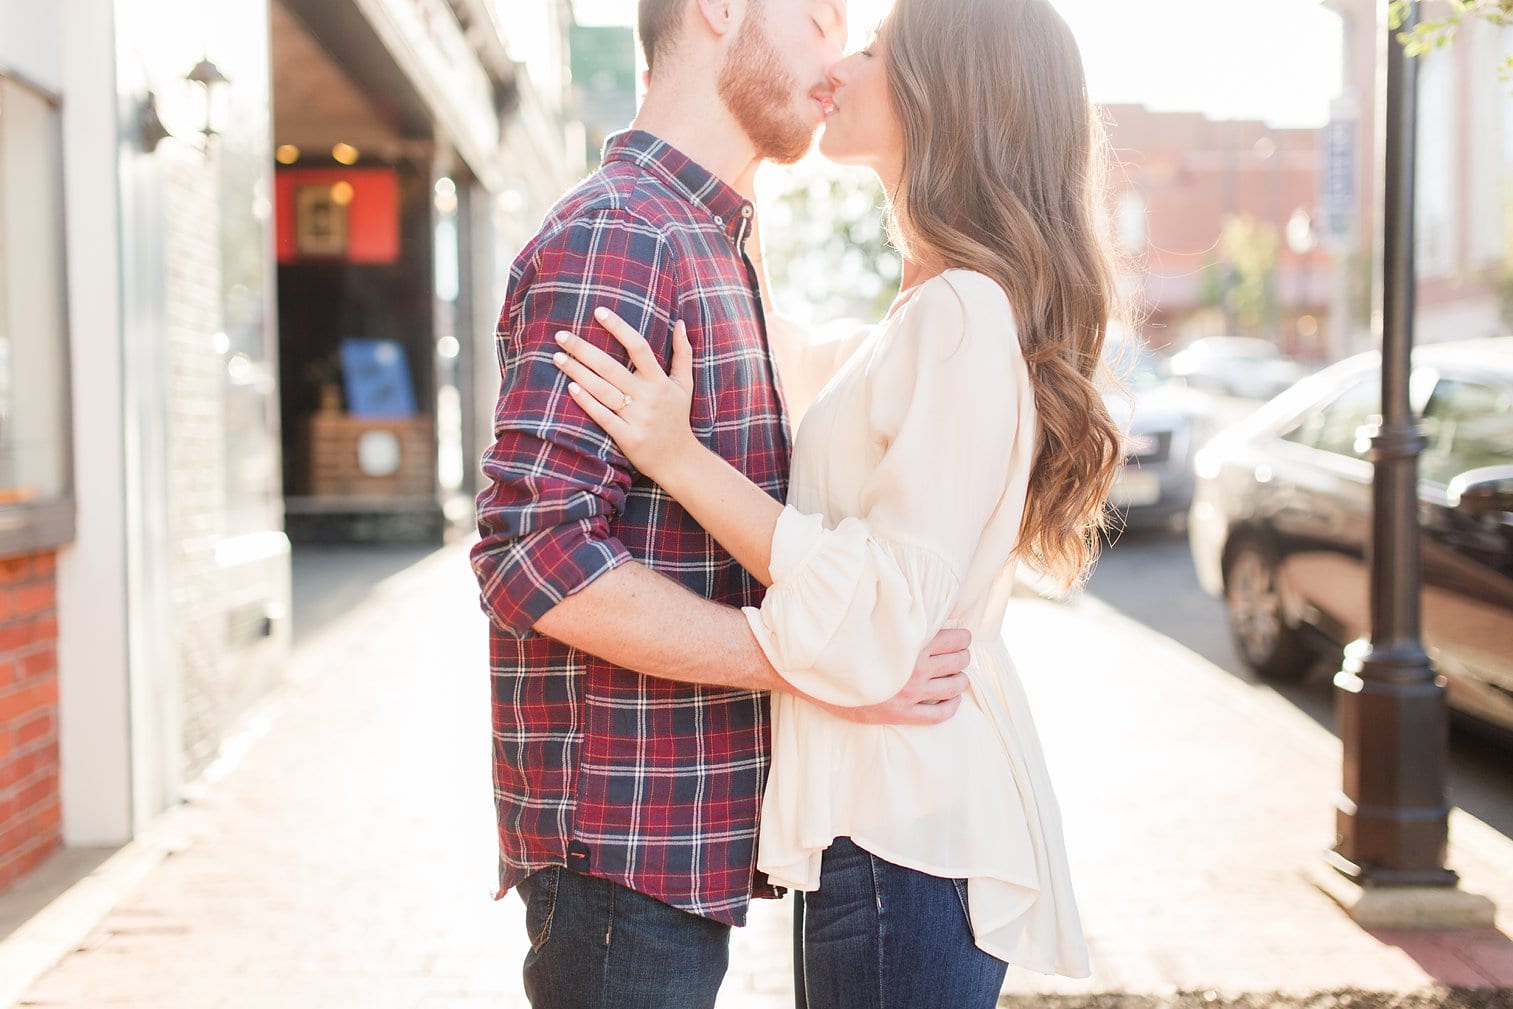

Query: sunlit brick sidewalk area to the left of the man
[11,548,527,1009]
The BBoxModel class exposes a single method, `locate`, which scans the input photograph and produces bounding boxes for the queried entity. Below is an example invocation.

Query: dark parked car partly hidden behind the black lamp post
[1188,337,1513,735]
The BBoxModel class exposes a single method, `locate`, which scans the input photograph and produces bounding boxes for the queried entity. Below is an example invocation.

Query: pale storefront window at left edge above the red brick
[0,76,73,555]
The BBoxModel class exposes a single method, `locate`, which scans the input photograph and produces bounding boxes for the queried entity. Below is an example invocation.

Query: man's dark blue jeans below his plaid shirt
[517,867,731,1009]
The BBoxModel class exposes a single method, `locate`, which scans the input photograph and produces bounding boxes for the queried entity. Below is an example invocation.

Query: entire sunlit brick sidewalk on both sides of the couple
[2,545,1513,1009]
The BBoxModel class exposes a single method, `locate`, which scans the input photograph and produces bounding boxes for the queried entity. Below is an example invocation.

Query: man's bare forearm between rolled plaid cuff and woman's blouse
[536,563,791,690]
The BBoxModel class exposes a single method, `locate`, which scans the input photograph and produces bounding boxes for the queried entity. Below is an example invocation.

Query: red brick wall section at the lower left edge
[0,552,62,889]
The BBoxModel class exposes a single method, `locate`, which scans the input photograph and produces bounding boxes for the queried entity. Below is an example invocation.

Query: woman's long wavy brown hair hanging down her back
[882,0,1124,590]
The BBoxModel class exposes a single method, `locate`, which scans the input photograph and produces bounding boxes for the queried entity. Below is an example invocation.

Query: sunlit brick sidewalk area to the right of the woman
[1006,599,1513,994]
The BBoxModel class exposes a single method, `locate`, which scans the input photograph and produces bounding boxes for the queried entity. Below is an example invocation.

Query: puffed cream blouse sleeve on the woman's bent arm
[744,275,1030,706]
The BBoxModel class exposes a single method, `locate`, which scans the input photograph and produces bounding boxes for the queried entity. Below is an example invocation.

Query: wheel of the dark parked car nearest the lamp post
[1224,540,1313,679]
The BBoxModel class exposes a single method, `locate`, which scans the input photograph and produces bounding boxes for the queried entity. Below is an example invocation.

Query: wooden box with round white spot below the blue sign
[309,413,436,498]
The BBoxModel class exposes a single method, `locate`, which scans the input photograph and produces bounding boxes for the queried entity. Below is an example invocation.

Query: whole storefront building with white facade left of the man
[0,0,586,889]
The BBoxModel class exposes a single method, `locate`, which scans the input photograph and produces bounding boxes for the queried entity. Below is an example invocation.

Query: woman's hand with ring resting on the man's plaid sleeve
[552,309,704,483]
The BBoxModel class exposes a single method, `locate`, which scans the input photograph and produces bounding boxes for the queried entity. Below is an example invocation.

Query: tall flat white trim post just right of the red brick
[57,0,133,846]
